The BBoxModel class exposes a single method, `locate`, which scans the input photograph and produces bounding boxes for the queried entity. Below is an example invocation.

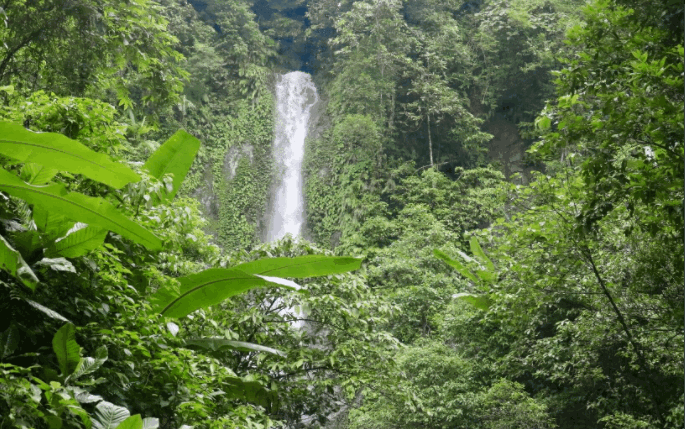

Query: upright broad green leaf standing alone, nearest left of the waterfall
[144,130,200,199]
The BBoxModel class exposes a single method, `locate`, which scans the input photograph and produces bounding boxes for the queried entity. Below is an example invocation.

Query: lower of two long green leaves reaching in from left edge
[0,169,162,250]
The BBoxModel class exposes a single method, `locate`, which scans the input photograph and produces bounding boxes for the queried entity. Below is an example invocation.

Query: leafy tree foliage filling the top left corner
[0,0,186,107]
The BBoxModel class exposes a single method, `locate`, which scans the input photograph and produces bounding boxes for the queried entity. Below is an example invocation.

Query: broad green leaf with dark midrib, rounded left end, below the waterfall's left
[151,268,273,317]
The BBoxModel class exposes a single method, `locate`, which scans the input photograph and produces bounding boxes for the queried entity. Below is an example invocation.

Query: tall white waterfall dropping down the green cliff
[266,71,319,241]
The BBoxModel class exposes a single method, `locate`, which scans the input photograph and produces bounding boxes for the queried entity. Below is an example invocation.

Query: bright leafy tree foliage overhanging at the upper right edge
[534,1,685,240]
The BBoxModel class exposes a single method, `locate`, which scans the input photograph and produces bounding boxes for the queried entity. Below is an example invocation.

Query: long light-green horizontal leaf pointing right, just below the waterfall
[234,255,362,279]
